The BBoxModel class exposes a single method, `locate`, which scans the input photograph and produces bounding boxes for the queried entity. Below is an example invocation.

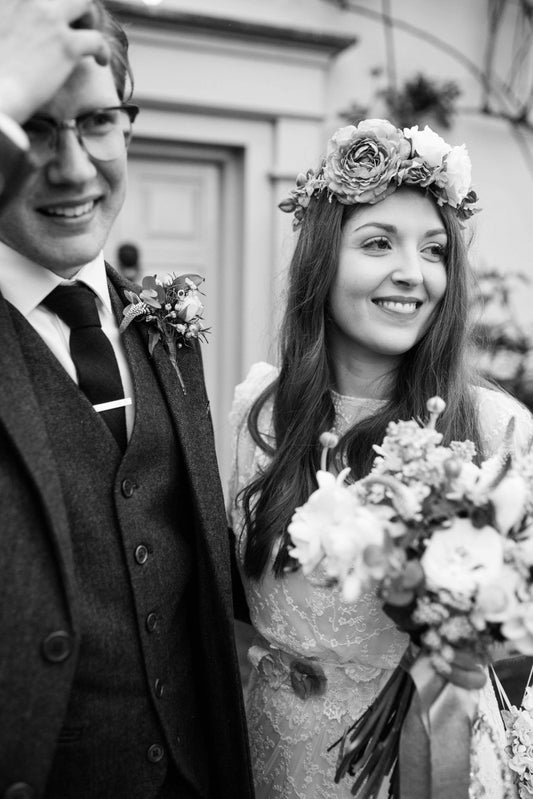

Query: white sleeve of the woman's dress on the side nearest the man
[228,361,278,530]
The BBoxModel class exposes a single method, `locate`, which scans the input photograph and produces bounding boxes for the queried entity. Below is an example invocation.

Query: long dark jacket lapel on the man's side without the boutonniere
[0,295,74,620]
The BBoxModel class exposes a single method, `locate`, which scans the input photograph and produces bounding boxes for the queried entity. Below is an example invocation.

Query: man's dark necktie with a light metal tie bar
[43,283,126,451]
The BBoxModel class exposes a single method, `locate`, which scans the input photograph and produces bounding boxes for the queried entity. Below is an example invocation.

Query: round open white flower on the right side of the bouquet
[420,518,503,598]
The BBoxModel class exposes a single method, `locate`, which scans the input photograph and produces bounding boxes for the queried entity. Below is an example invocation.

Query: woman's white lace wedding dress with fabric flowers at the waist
[230,363,533,799]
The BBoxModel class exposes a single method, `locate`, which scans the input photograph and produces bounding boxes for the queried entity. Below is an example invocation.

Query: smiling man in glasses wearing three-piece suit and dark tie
[0,7,252,799]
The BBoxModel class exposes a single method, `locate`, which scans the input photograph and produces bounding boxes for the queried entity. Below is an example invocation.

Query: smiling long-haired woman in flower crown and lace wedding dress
[230,120,533,799]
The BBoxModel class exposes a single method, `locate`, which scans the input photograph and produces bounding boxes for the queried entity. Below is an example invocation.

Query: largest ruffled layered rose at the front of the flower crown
[324,119,410,205]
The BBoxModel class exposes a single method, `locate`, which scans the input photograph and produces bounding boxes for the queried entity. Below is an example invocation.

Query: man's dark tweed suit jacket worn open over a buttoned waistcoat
[0,267,253,799]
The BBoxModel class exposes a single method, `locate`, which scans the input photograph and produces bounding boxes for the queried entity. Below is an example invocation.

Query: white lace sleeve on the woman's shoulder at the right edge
[477,388,533,457]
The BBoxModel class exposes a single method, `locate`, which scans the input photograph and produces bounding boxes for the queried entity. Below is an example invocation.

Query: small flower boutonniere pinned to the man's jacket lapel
[119,275,209,394]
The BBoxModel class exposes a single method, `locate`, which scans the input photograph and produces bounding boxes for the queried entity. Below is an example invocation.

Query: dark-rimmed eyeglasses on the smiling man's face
[23,103,139,167]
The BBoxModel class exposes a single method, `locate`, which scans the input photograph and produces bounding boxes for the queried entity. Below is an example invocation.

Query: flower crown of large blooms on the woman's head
[278,119,479,229]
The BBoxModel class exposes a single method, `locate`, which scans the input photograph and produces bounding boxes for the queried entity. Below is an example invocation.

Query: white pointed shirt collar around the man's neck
[0,242,112,317]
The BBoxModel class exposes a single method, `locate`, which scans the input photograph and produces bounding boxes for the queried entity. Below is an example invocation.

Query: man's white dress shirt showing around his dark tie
[0,242,135,438]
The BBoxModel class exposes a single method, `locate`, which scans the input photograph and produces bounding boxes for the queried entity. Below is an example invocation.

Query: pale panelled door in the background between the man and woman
[105,152,239,486]
